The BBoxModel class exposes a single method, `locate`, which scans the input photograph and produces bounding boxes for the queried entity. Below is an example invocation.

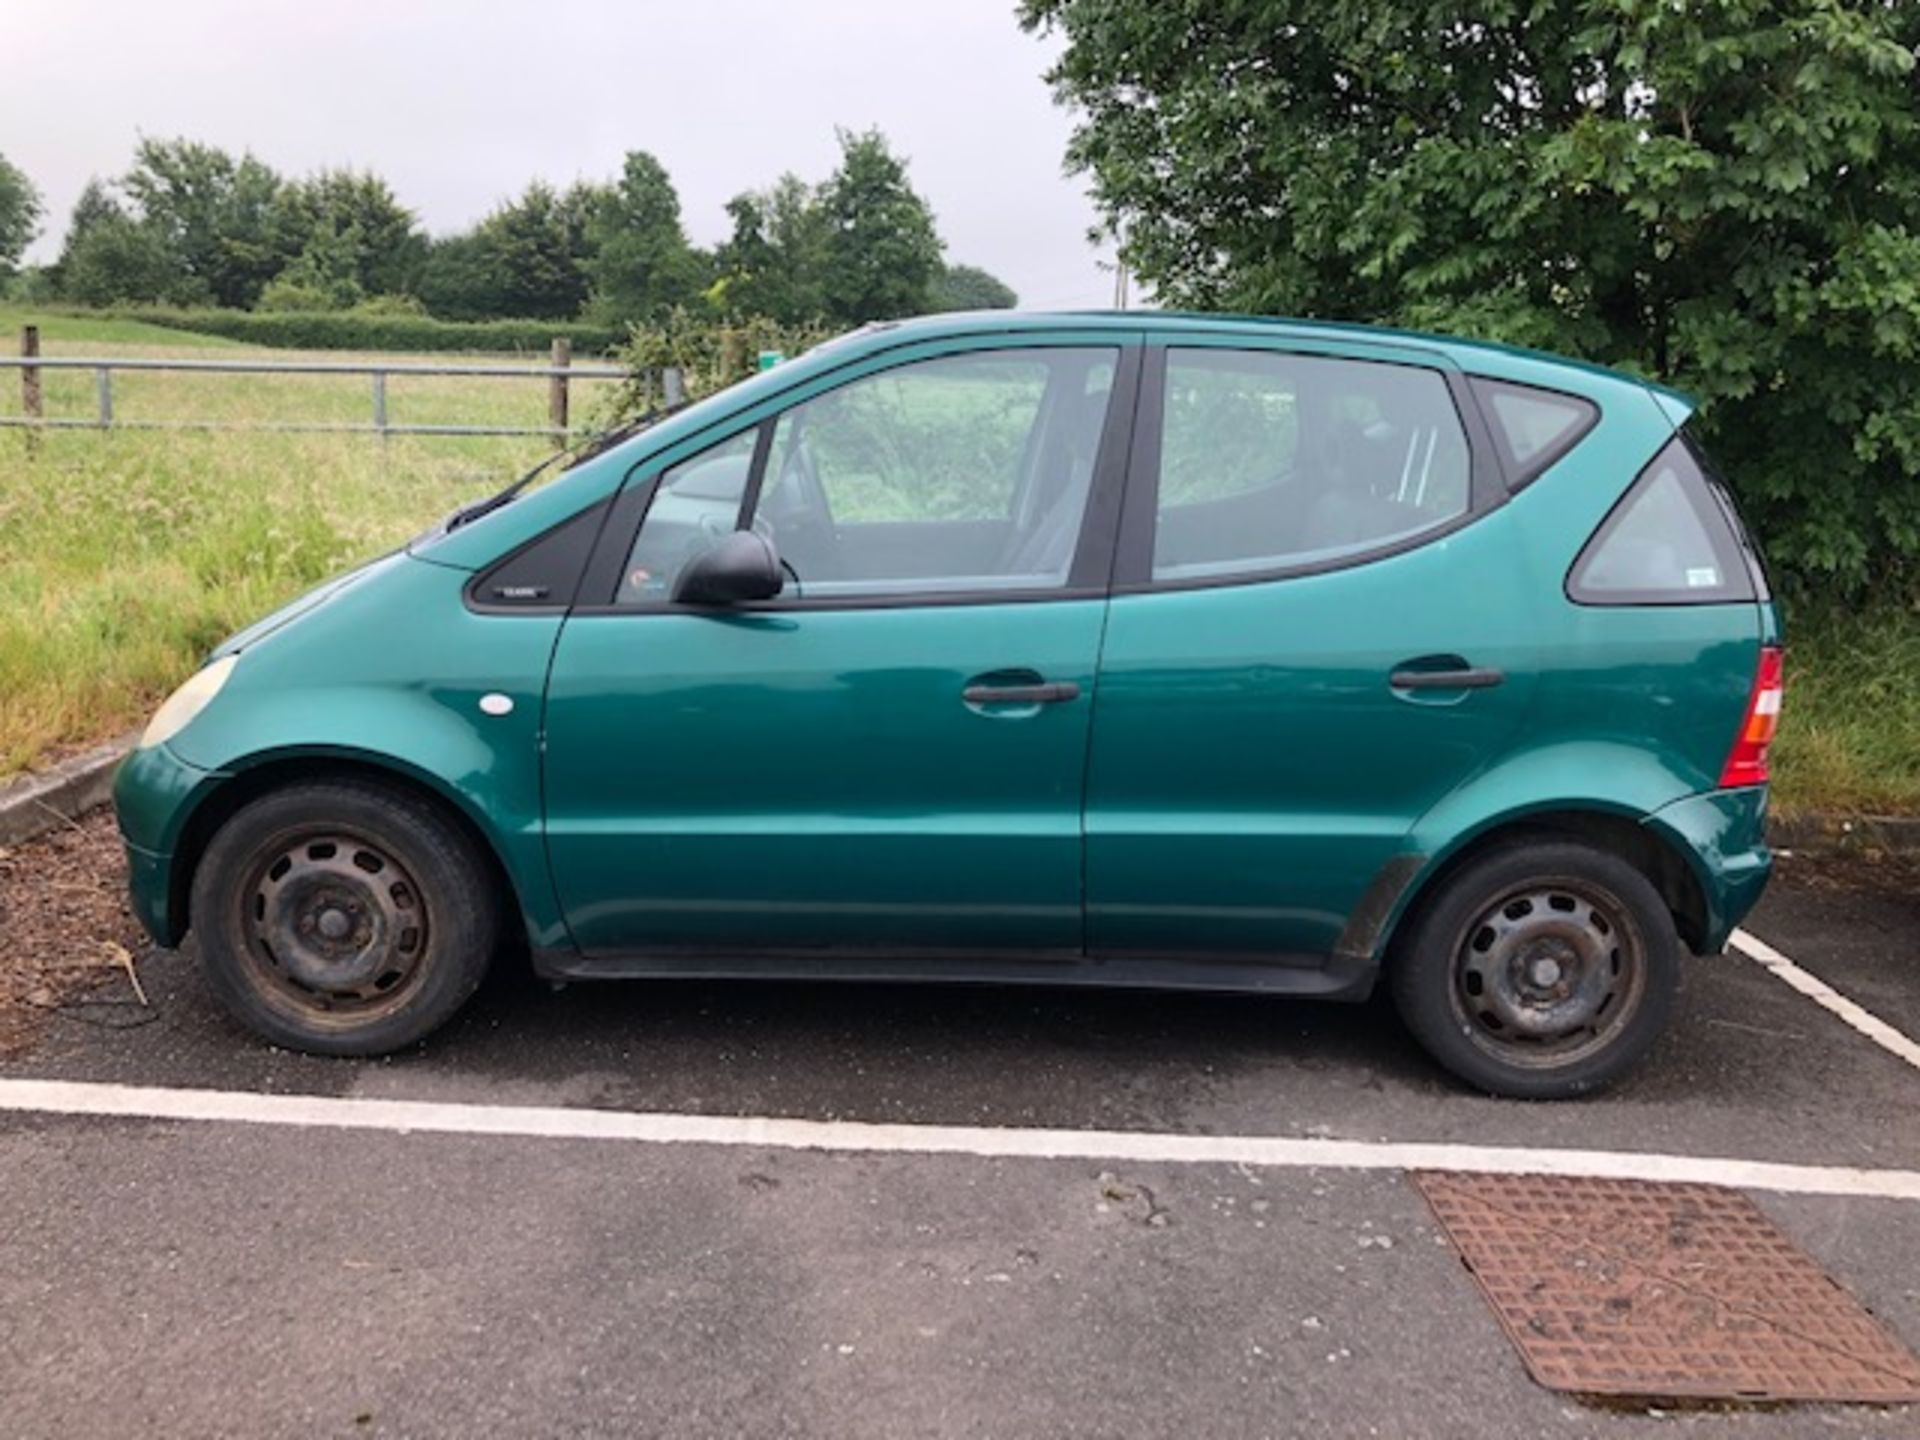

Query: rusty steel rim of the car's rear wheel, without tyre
[1450,879,1647,1069]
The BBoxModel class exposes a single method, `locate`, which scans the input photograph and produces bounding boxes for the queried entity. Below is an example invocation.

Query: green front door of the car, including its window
[545,344,1135,958]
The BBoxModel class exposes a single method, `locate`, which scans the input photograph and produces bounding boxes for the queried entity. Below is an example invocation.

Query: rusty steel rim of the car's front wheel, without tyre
[242,829,430,1021]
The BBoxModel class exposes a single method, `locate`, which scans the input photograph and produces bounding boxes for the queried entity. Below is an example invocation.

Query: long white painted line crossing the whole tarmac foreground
[0,1079,1920,1200]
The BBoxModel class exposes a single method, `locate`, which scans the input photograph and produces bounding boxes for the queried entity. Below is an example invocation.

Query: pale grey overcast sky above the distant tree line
[0,0,1112,307]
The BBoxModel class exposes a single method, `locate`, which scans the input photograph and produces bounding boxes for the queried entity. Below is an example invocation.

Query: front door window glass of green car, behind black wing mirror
[622,348,1117,603]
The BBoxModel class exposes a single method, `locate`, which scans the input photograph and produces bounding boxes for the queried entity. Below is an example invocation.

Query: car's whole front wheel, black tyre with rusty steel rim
[192,780,499,1056]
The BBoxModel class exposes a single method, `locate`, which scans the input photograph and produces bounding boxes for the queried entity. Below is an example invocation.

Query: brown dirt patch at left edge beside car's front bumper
[0,810,144,1058]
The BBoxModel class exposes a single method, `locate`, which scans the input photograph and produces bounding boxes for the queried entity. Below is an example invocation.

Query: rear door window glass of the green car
[1152,349,1471,580]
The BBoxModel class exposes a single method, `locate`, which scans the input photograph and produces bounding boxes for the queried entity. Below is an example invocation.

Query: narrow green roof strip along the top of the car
[844,309,1693,411]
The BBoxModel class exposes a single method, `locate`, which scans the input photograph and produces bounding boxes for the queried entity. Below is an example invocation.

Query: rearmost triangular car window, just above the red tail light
[1567,438,1759,605]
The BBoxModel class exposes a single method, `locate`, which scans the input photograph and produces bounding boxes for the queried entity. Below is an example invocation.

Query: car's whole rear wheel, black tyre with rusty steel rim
[1388,837,1680,1100]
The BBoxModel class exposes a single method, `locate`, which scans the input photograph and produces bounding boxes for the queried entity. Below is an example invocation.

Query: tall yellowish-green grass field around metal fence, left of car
[0,307,614,776]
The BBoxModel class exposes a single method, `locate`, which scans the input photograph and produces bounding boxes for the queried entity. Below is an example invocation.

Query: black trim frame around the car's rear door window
[1112,336,1509,595]
